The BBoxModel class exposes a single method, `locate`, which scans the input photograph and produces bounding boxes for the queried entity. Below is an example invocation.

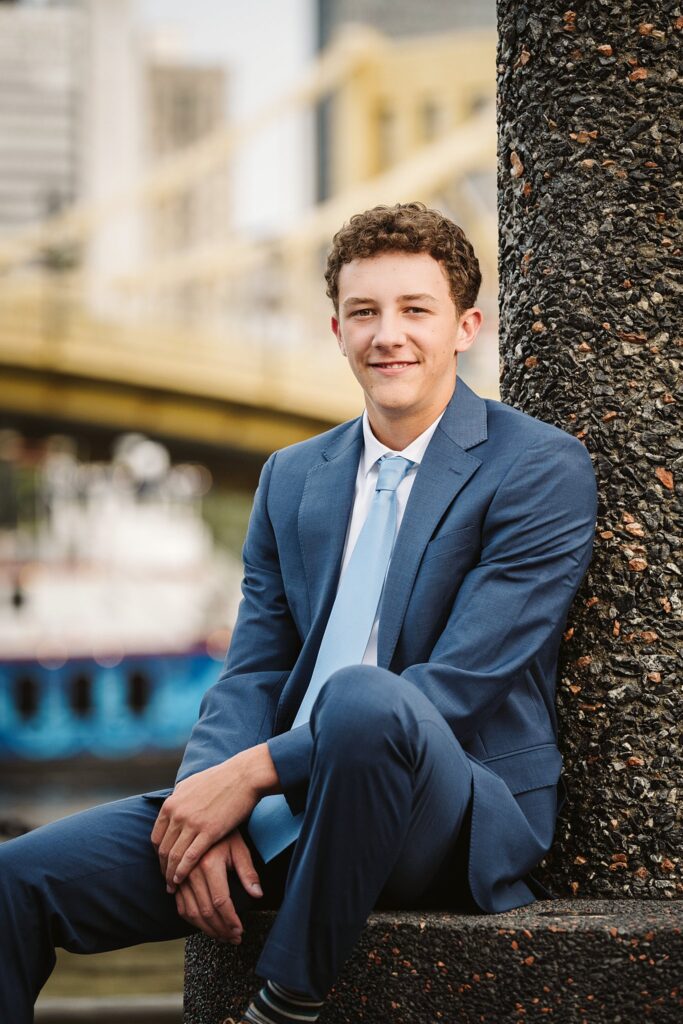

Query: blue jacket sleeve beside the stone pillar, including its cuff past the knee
[268,432,596,798]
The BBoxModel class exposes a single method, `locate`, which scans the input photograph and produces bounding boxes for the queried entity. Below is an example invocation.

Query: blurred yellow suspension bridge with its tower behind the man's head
[0,29,497,452]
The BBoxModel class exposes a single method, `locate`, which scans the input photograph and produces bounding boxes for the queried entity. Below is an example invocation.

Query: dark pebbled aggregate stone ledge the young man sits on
[184,899,683,1024]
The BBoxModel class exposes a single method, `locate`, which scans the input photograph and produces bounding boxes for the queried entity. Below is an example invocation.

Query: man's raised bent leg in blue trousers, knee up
[258,666,472,998]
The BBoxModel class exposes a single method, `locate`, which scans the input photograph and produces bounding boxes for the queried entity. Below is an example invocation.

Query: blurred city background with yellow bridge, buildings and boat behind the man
[0,0,498,1007]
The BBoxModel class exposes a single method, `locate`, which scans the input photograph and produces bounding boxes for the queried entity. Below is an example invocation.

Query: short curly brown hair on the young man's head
[325,203,481,312]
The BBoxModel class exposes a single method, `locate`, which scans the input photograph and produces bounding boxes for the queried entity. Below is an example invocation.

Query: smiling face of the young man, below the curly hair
[332,252,480,429]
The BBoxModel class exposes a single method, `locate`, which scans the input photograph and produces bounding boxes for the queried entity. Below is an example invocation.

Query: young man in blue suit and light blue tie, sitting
[0,203,596,1024]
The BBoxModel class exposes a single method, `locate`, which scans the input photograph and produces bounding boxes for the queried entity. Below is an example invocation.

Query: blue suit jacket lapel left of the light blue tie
[299,419,362,623]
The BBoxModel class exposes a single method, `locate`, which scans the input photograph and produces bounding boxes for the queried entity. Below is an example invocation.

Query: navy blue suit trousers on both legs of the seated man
[0,666,478,1024]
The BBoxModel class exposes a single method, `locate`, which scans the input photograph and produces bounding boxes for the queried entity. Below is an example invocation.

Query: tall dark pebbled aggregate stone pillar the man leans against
[498,0,683,901]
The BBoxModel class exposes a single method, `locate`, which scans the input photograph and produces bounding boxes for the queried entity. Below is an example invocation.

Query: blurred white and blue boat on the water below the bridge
[0,431,242,763]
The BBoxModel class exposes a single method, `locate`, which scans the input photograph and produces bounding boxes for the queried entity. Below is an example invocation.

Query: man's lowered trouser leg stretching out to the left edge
[0,797,191,1024]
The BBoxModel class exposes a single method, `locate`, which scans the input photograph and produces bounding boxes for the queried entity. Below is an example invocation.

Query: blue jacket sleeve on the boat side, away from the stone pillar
[176,453,301,782]
